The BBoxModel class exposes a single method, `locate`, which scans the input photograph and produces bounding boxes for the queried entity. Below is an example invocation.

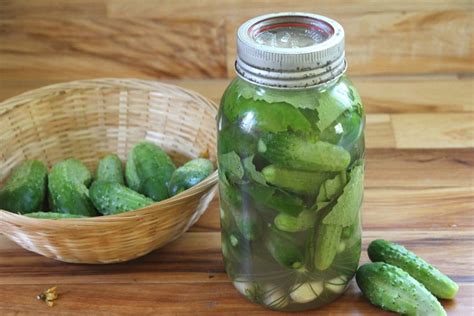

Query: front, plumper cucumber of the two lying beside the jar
[356,262,446,316]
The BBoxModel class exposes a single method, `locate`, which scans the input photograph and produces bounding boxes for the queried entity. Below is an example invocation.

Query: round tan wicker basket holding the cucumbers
[0,79,217,263]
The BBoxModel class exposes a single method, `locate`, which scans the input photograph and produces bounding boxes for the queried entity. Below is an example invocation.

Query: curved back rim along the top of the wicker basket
[0,77,219,116]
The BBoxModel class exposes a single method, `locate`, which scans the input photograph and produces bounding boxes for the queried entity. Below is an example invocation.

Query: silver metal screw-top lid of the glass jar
[235,12,347,89]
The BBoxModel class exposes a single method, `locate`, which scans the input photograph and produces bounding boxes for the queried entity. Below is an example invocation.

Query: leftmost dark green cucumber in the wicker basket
[0,160,48,214]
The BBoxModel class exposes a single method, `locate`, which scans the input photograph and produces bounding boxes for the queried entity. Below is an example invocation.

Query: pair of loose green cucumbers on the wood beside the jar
[356,239,459,316]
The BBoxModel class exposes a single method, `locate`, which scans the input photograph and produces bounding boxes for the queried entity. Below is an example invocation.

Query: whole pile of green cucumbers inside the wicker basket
[0,141,214,219]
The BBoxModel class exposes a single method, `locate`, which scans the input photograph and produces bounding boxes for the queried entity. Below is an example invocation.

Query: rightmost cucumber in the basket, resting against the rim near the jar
[168,158,214,196]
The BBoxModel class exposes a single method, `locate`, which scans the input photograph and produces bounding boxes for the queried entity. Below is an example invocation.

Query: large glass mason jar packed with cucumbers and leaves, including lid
[218,13,365,311]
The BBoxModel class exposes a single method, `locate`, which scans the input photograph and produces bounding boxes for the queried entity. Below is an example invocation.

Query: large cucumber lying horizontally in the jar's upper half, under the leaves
[258,133,351,171]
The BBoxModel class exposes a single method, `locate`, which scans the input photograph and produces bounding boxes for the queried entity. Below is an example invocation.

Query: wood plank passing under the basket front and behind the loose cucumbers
[0,228,474,286]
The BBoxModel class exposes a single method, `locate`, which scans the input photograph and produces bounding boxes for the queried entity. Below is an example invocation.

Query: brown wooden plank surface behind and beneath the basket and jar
[0,0,474,315]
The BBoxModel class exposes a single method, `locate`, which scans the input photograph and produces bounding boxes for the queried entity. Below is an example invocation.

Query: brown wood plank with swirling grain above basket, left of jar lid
[0,16,226,81]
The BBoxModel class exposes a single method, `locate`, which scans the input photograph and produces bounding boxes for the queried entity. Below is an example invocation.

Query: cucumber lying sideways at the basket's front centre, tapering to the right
[89,181,154,215]
